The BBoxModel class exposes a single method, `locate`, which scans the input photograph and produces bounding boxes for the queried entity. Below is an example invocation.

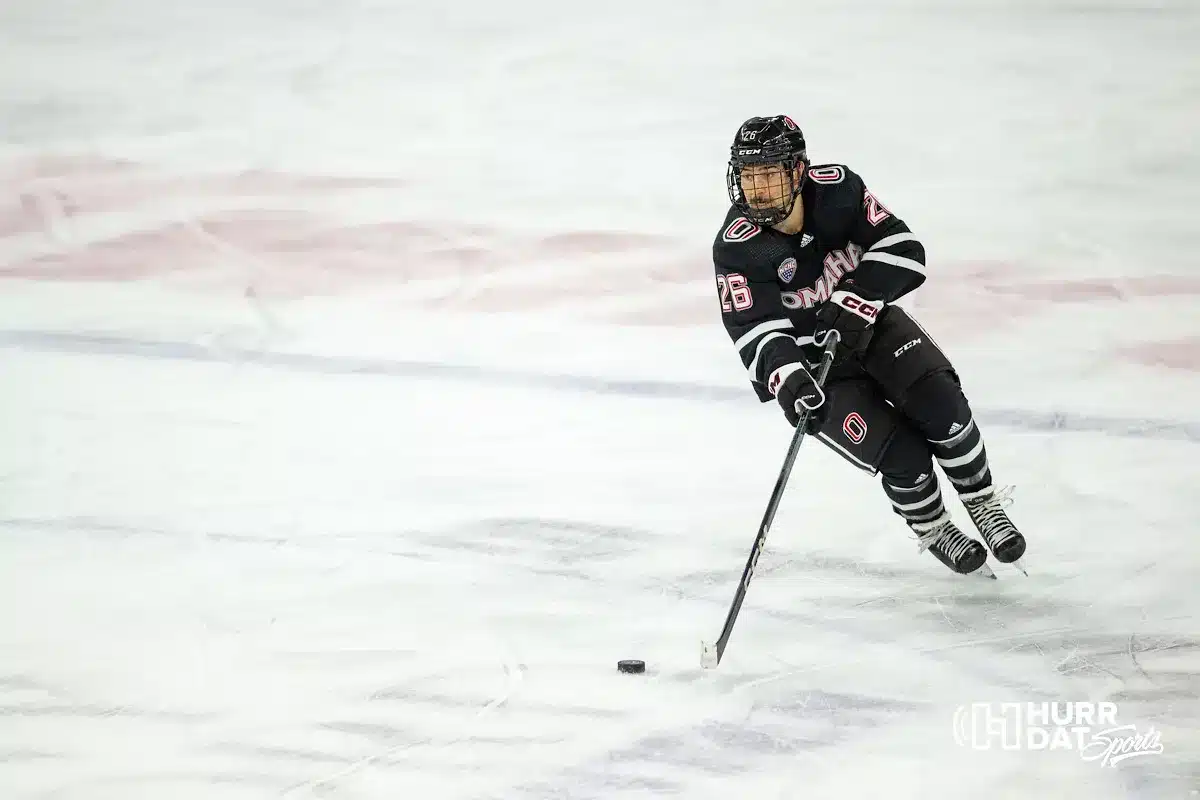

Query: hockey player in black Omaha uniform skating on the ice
[713,116,1025,575]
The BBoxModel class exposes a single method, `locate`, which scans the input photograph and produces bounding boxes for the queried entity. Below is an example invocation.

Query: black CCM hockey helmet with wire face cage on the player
[725,115,809,225]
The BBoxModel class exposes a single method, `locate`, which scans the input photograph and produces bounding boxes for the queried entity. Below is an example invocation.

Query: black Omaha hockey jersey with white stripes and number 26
[713,164,925,402]
